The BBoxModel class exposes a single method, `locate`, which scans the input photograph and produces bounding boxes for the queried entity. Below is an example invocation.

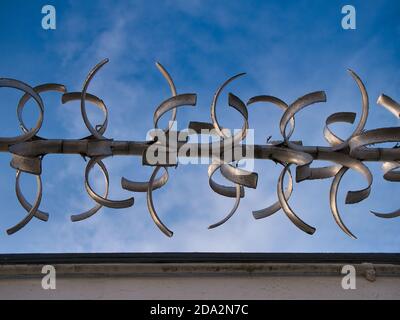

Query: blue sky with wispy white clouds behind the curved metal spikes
[0,0,400,252]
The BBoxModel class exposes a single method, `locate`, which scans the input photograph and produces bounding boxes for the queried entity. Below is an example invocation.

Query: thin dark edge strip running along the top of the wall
[0,252,400,265]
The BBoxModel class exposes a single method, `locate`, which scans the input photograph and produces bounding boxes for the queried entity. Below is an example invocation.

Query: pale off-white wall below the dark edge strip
[0,263,400,299]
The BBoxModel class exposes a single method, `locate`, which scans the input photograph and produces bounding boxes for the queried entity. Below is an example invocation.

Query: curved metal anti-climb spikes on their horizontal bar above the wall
[0,59,400,238]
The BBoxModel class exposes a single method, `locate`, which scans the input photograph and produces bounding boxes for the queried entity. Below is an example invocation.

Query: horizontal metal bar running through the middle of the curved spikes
[0,139,400,162]
